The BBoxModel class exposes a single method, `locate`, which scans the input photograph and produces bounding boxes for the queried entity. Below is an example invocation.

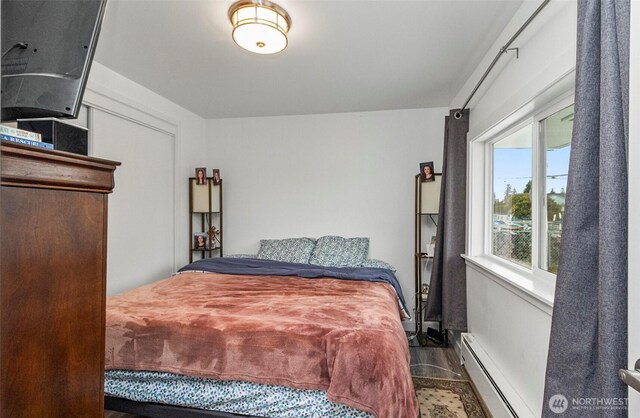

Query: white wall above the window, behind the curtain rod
[451,0,577,139]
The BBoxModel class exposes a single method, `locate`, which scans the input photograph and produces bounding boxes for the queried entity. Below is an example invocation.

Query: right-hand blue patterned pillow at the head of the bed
[309,235,369,267]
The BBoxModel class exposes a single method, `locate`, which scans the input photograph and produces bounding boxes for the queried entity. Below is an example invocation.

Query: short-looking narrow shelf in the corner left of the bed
[189,177,224,262]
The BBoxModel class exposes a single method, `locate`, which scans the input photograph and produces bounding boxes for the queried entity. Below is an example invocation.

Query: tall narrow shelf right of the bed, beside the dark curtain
[414,174,442,346]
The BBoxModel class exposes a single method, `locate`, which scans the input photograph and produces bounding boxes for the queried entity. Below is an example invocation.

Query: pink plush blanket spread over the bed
[106,272,418,418]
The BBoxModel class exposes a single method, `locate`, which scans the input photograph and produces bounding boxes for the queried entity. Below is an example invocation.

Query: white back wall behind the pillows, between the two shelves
[207,108,448,324]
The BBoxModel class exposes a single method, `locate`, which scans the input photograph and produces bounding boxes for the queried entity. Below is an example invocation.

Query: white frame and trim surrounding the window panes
[464,81,575,307]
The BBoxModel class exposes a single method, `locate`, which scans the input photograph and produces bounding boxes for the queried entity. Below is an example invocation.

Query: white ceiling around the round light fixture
[95,0,522,118]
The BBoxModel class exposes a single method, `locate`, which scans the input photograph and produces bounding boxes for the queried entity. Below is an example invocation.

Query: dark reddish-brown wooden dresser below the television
[0,143,120,418]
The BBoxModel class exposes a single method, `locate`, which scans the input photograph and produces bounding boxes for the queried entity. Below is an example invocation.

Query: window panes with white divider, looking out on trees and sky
[486,100,573,275]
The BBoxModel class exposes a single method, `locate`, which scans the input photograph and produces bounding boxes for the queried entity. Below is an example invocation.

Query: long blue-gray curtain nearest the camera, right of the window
[543,0,630,418]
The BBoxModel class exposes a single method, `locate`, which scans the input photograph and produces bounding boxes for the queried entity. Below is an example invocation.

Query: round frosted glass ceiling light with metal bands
[229,0,291,54]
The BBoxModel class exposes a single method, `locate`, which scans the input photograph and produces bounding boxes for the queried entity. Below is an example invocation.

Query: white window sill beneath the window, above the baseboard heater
[462,254,555,315]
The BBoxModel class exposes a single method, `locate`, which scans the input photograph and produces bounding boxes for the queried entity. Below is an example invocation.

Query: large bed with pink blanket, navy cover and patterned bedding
[105,237,418,418]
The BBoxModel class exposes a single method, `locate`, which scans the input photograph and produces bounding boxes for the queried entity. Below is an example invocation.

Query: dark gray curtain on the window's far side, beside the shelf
[424,109,469,331]
